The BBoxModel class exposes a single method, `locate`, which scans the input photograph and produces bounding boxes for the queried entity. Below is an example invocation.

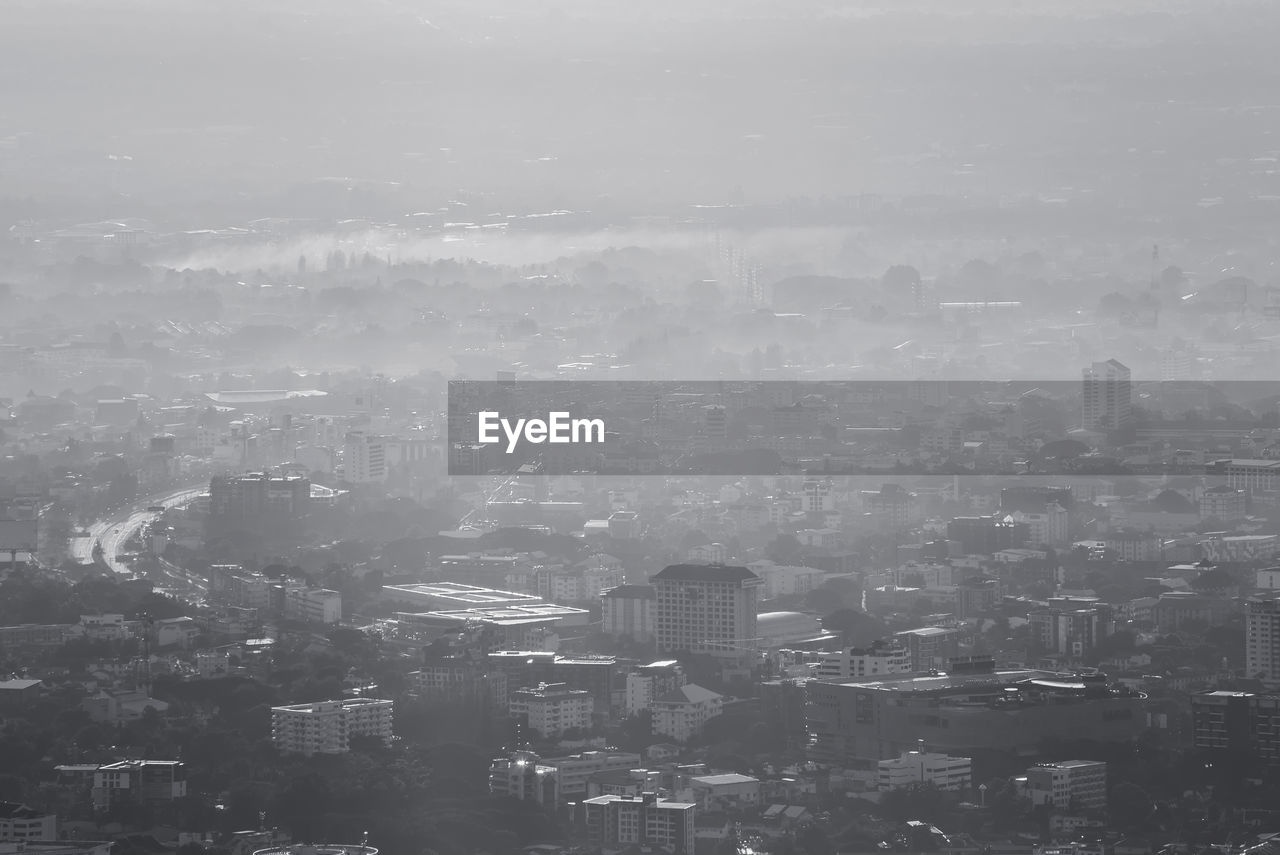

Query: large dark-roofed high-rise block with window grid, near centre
[652,564,762,660]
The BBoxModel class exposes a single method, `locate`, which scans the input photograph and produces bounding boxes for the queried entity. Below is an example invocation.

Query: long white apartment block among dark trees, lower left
[271,698,396,755]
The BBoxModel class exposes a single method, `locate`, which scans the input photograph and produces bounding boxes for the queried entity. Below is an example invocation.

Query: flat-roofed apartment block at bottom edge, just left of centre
[582,792,698,855]
